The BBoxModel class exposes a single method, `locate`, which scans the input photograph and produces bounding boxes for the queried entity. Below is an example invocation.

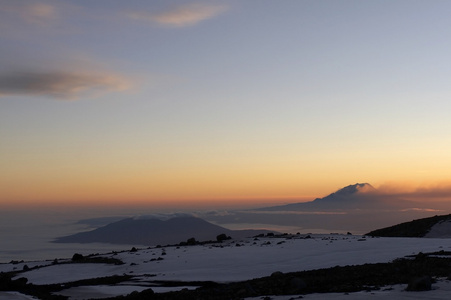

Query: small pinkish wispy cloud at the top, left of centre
[128,3,227,27]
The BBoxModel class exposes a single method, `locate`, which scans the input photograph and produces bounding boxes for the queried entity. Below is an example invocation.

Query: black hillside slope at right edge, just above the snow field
[366,215,451,238]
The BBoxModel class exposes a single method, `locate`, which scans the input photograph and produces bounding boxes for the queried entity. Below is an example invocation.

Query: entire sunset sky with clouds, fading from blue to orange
[0,0,451,207]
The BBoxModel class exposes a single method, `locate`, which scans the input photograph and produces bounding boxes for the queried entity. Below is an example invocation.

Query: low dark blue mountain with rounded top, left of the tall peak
[54,217,268,246]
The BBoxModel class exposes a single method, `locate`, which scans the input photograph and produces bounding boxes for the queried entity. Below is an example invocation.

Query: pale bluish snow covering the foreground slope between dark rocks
[0,235,451,300]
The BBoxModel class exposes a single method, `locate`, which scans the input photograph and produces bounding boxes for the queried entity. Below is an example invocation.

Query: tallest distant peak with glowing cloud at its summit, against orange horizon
[258,183,416,211]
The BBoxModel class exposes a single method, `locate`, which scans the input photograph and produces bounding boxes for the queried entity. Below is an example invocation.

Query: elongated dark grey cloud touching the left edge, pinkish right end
[0,71,130,99]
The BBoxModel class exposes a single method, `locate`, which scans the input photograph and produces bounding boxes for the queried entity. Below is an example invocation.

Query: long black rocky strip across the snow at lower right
[101,253,451,300]
